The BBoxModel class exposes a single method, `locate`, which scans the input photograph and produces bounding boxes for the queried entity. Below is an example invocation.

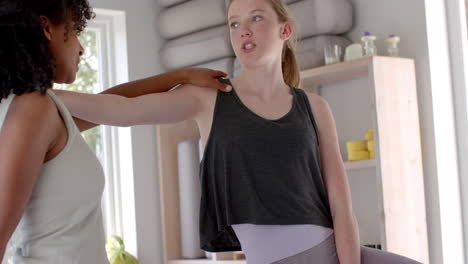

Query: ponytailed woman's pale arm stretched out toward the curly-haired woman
[55,85,203,126]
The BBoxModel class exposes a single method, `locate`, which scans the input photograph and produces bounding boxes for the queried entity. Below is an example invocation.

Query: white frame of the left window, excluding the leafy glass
[87,8,137,255]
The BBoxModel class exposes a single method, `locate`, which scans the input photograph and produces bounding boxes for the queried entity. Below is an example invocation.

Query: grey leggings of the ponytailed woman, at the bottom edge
[273,236,421,264]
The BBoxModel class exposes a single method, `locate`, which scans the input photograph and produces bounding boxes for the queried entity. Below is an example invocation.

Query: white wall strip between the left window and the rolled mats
[90,0,162,264]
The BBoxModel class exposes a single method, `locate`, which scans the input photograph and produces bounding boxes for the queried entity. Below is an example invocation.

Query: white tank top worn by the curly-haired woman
[0,90,108,264]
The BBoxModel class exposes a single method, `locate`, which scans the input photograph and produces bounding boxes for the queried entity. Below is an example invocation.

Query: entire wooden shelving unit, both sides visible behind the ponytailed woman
[157,57,429,264]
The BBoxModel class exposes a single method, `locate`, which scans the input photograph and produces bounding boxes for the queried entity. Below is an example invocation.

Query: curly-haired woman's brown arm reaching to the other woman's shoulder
[74,68,230,131]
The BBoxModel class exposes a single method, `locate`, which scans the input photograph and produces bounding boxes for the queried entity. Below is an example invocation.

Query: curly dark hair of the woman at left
[0,0,95,100]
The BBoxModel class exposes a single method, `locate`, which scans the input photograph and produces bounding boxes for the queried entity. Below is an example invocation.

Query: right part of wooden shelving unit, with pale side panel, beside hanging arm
[301,56,429,263]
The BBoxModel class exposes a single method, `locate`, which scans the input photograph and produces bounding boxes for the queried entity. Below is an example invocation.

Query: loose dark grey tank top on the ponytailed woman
[200,82,333,252]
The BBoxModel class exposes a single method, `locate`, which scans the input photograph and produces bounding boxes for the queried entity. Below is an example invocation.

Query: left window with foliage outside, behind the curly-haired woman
[57,8,137,255]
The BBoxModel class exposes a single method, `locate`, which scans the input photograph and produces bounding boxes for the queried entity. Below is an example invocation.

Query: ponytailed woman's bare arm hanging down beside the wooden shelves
[308,93,361,264]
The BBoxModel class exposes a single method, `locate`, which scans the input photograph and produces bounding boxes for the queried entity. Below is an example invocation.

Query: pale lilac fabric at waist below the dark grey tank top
[232,224,333,264]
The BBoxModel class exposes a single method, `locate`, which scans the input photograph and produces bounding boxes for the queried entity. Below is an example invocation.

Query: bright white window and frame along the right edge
[432,0,468,263]
